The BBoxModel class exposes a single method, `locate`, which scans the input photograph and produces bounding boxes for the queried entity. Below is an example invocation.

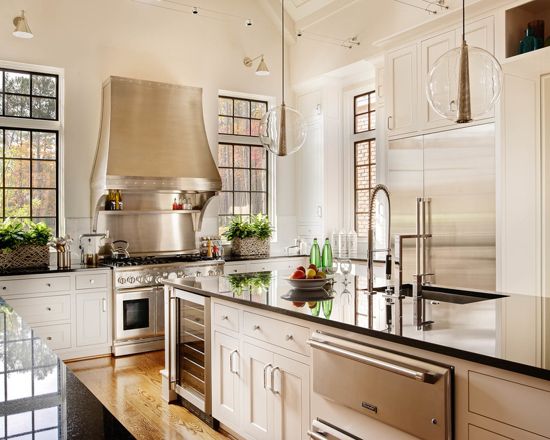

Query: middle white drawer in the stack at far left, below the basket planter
[9,295,71,324]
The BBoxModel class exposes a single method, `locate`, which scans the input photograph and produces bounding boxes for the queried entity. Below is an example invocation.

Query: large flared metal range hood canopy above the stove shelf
[92,76,222,204]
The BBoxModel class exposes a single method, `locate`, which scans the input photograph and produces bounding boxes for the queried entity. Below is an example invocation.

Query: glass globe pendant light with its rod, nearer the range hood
[260,0,306,156]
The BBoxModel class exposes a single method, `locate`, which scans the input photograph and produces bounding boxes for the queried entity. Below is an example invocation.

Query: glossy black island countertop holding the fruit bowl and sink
[166,272,550,380]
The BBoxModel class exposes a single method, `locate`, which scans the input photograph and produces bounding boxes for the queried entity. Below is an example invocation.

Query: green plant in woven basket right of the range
[224,214,273,256]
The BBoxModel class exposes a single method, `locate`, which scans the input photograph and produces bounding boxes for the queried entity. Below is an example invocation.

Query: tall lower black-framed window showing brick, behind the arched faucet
[354,138,376,237]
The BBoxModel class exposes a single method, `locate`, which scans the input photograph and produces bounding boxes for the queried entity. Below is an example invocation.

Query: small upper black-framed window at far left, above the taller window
[0,68,59,121]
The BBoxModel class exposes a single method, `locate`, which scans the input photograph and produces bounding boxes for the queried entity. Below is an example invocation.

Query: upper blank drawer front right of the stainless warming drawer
[468,371,550,437]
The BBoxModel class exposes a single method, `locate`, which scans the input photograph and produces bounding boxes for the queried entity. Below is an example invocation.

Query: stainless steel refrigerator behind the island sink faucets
[387,123,496,290]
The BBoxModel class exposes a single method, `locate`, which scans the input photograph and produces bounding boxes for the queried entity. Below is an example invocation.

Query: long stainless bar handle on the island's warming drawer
[307,339,439,384]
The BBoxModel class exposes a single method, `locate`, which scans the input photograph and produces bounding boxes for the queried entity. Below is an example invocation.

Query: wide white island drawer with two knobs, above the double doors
[243,312,309,356]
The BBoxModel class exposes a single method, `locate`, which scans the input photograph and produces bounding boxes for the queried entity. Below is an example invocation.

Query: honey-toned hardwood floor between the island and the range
[67,351,228,440]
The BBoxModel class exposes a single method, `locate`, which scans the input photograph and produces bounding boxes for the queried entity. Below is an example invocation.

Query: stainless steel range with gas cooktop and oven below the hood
[104,254,224,356]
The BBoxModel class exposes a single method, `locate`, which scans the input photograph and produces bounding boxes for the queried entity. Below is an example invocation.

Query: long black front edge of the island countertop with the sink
[163,280,550,380]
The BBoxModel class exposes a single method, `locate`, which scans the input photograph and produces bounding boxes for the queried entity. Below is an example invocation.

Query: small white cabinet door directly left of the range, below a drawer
[76,291,109,346]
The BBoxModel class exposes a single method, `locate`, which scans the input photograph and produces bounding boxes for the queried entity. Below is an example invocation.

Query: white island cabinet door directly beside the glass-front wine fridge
[212,331,241,431]
